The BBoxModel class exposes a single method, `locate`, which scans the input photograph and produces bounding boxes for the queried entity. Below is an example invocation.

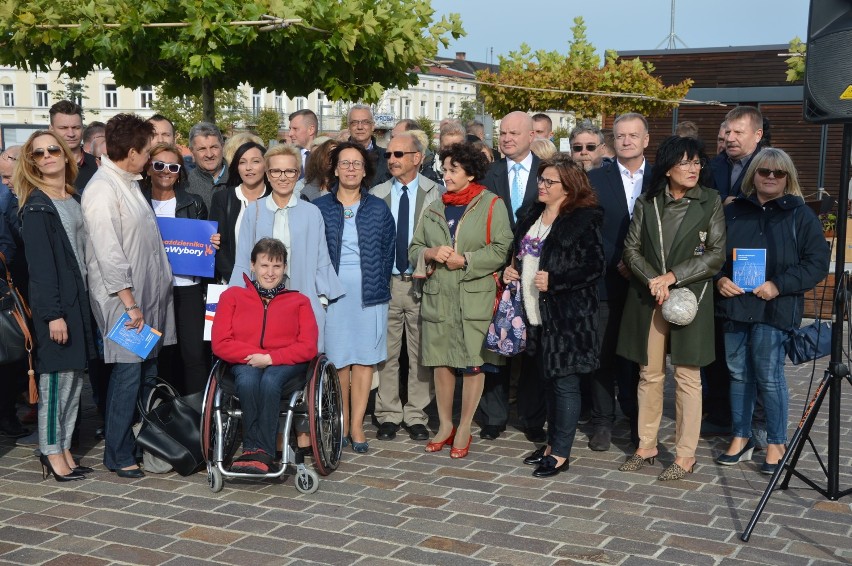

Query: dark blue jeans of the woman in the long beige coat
[104,358,157,470]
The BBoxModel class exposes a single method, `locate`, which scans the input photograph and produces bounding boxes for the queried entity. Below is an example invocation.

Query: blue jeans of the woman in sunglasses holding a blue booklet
[725,322,788,444]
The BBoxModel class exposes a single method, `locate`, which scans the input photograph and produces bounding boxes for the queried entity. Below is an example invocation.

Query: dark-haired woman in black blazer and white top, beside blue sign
[210,141,272,283]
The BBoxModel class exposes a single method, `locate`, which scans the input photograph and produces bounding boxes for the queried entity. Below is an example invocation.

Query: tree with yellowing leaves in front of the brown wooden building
[476,17,692,117]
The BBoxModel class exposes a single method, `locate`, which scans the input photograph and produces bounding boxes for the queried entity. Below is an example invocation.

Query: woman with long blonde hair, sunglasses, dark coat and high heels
[16,131,95,482]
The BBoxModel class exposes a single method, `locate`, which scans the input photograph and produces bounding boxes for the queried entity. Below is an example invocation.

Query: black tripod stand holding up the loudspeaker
[740,123,852,542]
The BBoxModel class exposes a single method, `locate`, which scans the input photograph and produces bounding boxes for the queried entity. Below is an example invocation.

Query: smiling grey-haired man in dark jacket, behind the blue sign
[187,122,228,210]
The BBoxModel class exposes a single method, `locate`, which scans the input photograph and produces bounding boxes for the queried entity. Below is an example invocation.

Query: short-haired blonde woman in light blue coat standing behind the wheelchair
[229,144,344,352]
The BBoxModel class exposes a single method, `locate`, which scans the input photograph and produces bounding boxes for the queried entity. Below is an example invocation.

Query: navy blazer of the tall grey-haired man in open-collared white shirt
[589,161,653,302]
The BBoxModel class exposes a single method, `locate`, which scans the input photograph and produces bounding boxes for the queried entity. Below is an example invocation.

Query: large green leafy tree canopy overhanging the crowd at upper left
[0,0,464,121]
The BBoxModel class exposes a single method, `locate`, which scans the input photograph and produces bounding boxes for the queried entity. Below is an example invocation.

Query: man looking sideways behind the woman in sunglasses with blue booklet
[710,106,763,204]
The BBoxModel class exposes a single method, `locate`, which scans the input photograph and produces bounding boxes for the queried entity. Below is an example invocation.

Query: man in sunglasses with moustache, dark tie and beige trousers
[370,132,442,440]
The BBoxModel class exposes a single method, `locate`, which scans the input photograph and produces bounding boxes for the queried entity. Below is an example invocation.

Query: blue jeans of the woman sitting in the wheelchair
[231,364,308,456]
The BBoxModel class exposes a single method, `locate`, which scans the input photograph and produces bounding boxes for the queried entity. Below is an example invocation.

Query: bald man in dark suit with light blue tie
[479,111,546,440]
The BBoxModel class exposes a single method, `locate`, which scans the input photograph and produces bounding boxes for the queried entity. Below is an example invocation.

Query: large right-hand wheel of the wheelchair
[308,355,343,476]
